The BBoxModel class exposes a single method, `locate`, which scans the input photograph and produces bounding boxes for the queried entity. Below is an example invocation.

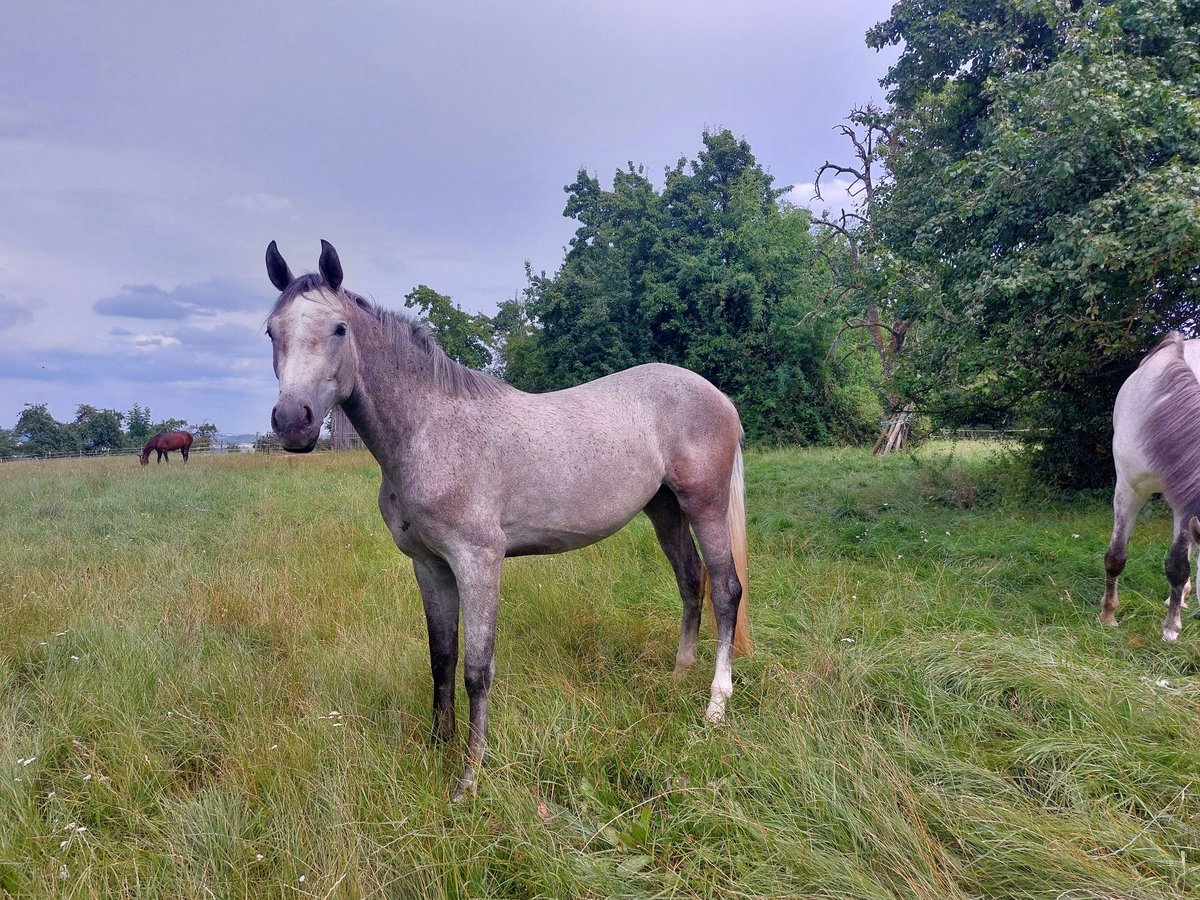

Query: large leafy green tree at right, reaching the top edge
[868,0,1200,485]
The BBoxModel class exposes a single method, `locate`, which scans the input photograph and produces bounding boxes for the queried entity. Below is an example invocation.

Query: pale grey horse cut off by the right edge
[1100,332,1200,643]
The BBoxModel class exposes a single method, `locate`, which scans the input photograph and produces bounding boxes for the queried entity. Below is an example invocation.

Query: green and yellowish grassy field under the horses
[0,445,1200,899]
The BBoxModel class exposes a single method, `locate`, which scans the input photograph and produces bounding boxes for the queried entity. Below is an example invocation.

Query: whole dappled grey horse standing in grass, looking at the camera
[266,241,750,799]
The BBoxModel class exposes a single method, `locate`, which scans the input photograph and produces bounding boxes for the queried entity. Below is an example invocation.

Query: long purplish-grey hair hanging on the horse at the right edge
[1139,332,1200,514]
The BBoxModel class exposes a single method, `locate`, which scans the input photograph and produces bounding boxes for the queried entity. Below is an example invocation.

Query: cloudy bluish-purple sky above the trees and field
[0,0,896,434]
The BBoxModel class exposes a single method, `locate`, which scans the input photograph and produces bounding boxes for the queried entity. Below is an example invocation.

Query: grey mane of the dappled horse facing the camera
[271,272,508,397]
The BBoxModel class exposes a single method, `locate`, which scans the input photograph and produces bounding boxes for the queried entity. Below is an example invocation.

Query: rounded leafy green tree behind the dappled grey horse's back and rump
[503,131,877,442]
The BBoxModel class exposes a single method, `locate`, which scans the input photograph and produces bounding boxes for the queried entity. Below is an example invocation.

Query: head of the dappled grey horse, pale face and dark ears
[266,241,358,452]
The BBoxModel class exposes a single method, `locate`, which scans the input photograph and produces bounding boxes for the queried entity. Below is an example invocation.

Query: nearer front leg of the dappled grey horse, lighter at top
[450,550,504,803]
